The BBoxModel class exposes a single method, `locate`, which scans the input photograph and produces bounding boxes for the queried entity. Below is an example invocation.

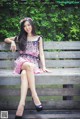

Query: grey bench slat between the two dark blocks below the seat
[0,88,80,97]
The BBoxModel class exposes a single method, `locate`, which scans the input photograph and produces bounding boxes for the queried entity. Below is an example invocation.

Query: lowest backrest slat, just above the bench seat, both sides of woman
[0,60,80,69]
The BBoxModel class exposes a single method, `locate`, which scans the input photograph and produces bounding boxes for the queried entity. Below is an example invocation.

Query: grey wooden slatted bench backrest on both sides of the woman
[0,41,80,69]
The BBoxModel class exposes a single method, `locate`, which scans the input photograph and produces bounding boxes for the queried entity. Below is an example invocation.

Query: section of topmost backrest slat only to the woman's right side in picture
[44,41,80,50]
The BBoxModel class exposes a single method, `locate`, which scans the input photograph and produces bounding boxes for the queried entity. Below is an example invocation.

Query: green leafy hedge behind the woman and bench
[0,0,80,41]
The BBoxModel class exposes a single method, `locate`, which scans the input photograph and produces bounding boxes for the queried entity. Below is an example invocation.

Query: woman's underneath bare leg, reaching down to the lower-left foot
[16,70,28,116]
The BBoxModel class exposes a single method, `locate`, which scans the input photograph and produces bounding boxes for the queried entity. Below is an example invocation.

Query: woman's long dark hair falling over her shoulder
[18,18,36,51]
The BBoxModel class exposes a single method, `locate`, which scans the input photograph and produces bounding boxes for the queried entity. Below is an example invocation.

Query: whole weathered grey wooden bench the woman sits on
[0,41,80,119]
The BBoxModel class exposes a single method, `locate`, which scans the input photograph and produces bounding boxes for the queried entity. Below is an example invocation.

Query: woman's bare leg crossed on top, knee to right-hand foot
[22,62,41,105]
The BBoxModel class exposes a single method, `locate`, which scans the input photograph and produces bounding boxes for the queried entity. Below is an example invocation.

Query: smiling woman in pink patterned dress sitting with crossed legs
[5,17,48,119]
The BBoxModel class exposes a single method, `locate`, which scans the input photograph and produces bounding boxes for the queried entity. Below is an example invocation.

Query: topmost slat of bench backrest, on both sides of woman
[0,41,80,50]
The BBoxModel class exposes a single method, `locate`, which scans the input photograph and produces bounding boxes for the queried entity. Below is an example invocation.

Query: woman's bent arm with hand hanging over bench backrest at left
[4,37,16,52]
